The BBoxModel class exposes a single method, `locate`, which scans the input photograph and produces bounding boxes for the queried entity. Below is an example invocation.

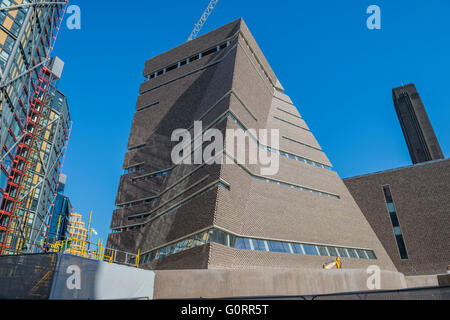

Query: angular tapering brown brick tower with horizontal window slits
[108,19,396,271]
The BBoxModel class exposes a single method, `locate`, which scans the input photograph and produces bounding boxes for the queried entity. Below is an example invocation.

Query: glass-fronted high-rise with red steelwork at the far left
[0,0,71,254]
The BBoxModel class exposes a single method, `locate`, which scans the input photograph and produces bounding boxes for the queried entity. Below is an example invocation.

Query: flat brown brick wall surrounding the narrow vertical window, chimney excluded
[344,159,450,275]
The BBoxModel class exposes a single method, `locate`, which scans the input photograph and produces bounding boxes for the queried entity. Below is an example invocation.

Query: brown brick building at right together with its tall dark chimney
[344,84,450,276]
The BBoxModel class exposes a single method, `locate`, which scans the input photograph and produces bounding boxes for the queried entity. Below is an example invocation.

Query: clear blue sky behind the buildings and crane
[54,0,450,245]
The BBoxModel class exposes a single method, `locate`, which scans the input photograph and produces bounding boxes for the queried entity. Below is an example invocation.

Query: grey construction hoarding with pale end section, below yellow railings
[0,253,155,300]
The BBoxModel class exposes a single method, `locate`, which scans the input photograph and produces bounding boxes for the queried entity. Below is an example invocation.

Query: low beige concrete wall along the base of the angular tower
[154,268,406,299]
